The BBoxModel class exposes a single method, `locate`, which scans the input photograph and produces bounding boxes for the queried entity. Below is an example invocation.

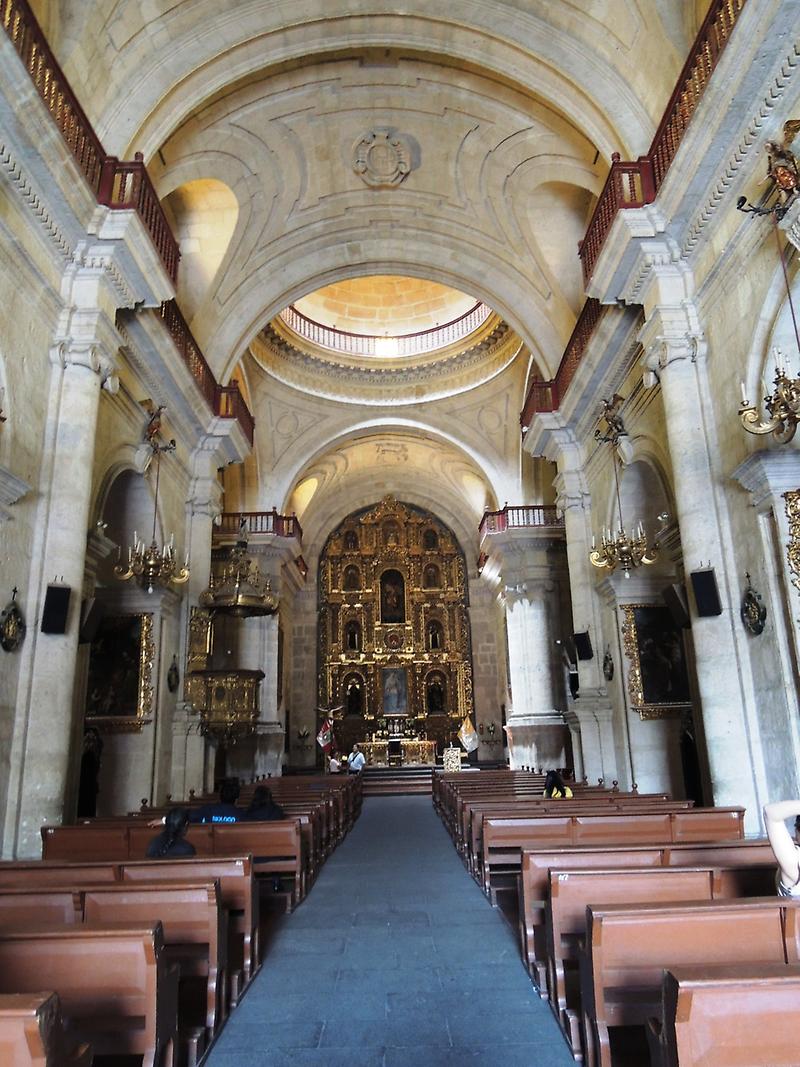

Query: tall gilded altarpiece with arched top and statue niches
[319,497,473,752]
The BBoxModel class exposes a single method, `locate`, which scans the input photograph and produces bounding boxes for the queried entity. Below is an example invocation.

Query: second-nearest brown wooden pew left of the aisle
[0,923,178,1067]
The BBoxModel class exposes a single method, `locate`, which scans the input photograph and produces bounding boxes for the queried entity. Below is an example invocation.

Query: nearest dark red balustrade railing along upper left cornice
[0,0,180,282]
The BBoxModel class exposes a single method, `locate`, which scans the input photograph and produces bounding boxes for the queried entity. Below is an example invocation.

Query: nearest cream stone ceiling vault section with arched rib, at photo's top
[40,0,682,158]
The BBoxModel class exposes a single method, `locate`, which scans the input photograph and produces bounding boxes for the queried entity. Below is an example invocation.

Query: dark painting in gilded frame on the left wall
[85,611,156,733]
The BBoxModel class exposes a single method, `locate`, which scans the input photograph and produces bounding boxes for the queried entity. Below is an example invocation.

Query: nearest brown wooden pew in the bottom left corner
[0,993,92,1067]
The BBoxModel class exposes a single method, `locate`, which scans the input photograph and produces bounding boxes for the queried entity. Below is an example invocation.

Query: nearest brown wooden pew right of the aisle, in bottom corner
[647,964,800,1067]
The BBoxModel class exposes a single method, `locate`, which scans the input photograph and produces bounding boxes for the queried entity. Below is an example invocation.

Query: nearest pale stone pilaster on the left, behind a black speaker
[5,341,118,857]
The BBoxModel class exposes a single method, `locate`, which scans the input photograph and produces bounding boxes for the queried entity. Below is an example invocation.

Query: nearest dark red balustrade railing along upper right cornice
[578,0,746,286]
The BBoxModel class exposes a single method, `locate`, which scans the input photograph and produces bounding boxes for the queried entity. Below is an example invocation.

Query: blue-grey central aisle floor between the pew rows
[207,796,574,1067]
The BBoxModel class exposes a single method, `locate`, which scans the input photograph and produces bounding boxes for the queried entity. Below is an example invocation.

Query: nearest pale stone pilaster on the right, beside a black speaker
[641,324,766,832]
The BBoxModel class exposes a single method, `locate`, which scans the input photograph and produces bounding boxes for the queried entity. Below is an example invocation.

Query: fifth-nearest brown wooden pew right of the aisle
[481,808,745,895]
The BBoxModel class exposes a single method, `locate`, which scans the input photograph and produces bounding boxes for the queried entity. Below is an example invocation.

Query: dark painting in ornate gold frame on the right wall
[620,604,691,719]
